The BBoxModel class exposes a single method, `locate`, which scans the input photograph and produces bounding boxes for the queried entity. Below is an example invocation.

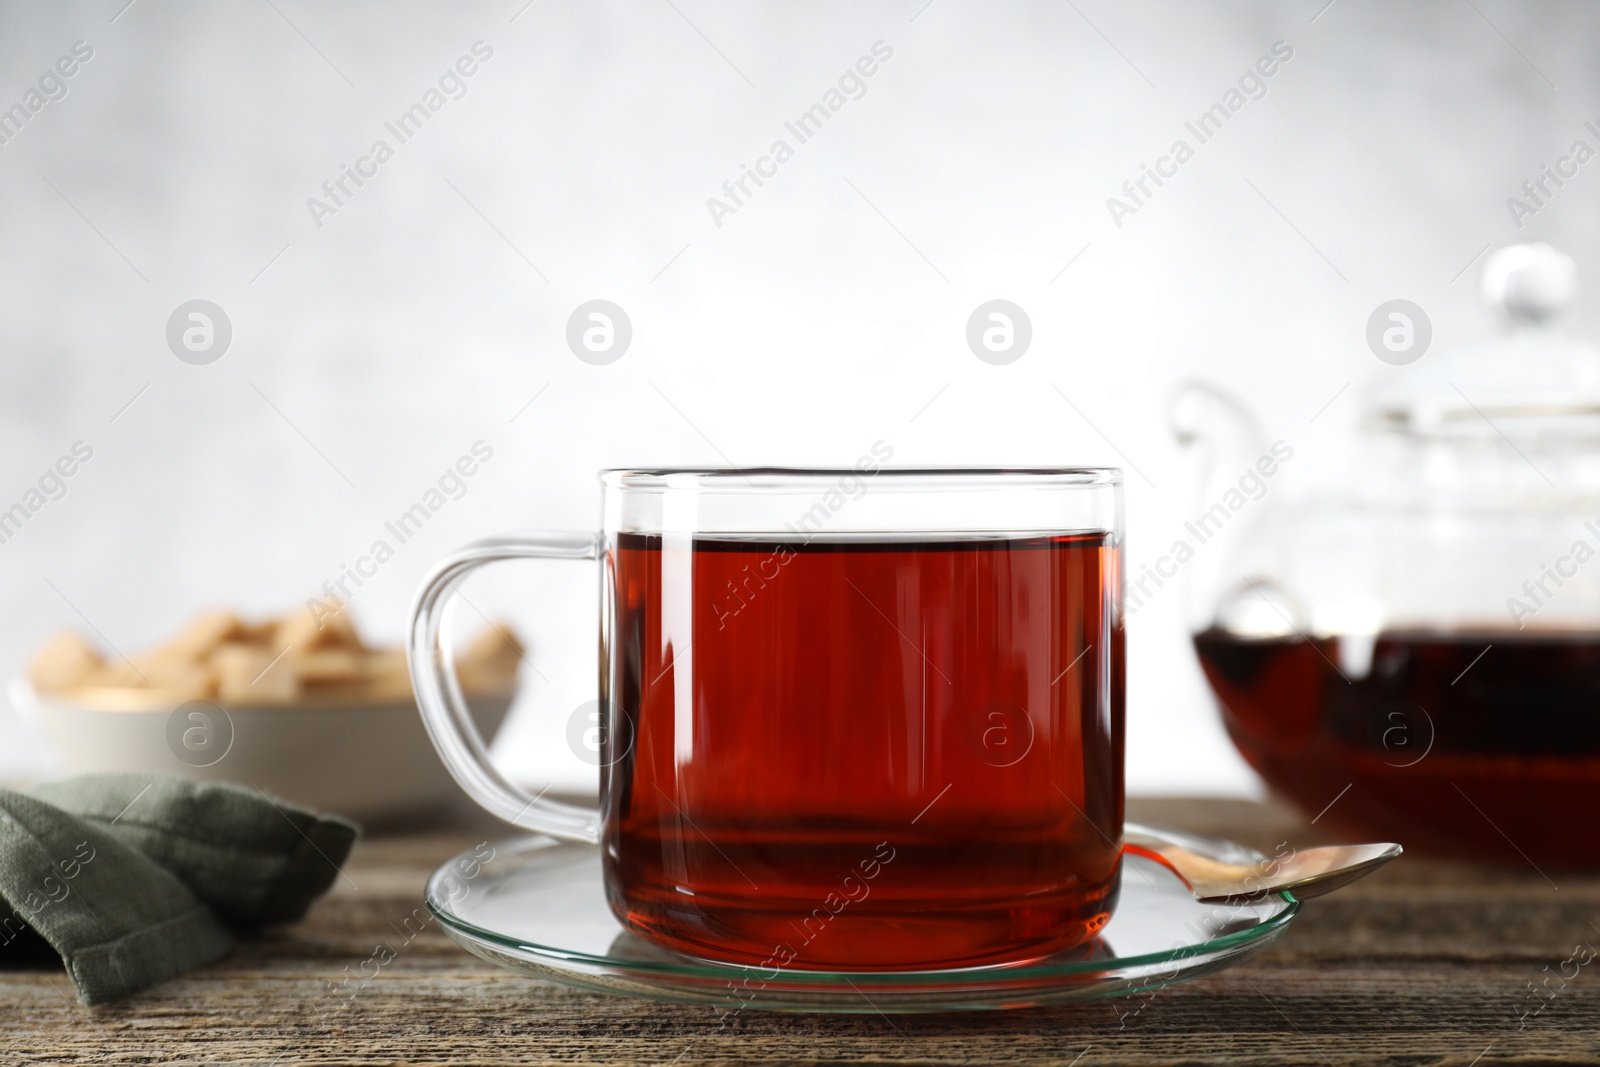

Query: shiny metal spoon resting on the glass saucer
[1122,822,1403,904]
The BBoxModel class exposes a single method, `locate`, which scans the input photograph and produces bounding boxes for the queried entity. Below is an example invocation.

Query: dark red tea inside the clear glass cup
[602,533,1123,969]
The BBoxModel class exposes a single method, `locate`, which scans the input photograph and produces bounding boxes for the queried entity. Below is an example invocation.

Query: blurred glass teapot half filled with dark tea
[1177,245,1600,869]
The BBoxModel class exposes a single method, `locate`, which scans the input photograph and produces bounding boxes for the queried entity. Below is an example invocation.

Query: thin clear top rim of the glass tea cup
[600,467,1123,493]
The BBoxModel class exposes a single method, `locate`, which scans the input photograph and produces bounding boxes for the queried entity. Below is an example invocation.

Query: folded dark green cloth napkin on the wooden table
[0,774,358,1005]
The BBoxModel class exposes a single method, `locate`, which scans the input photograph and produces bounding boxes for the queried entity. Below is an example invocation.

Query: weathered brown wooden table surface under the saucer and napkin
[0,800,1600,1067]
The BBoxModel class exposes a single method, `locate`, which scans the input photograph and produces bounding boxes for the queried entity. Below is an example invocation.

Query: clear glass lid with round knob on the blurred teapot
[1366,243,1600,442]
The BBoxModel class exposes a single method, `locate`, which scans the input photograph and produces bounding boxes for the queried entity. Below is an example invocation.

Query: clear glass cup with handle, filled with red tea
[410,458,1125,969]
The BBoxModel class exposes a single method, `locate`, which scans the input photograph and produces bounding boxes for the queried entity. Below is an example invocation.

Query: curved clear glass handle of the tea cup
[406,533,600,843]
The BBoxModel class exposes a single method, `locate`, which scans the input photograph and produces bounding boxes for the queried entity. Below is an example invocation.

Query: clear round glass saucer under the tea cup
[427,835,1299,1013]
